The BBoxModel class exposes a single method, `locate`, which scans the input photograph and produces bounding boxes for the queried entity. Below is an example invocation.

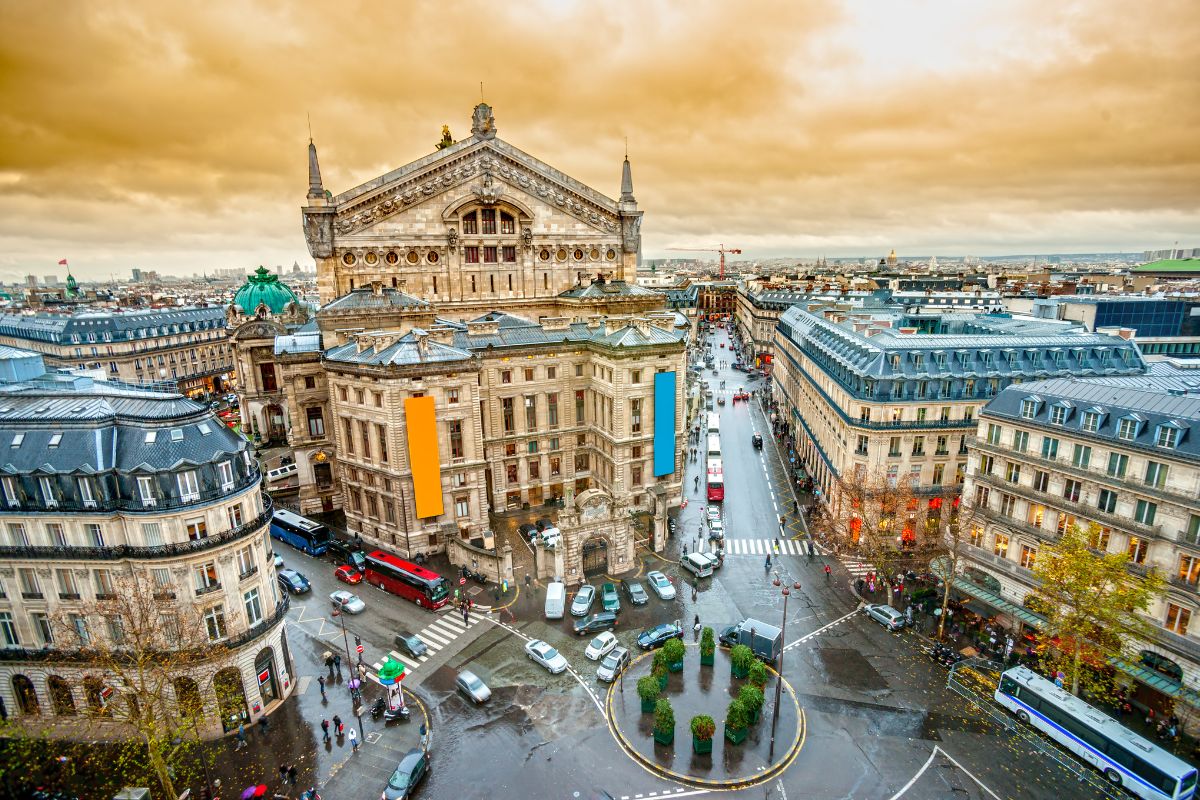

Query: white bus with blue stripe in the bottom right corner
[995,667,1196,800]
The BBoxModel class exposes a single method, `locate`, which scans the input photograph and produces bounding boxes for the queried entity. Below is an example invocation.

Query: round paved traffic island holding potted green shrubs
[605,644,805,790]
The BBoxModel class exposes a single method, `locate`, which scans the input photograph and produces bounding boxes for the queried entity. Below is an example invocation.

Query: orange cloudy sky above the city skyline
[0,0,1200,279]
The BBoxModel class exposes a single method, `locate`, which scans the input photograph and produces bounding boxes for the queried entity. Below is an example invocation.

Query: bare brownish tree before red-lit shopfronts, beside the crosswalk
[814,473,952,602]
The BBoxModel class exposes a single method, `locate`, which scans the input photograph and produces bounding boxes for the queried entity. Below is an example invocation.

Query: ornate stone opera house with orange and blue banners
[230,103,689,582]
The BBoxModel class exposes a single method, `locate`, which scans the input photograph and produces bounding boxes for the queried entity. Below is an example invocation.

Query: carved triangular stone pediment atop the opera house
[334,139,620,236]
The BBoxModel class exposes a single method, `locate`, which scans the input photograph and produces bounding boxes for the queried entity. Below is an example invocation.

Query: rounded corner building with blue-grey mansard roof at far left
[0,348,293,738]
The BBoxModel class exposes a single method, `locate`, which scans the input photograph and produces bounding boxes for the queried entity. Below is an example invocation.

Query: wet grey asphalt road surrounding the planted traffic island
[258,331,1108,800]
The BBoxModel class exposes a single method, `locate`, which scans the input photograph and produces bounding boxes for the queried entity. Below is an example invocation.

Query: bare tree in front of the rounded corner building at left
[52,570,227,798]
